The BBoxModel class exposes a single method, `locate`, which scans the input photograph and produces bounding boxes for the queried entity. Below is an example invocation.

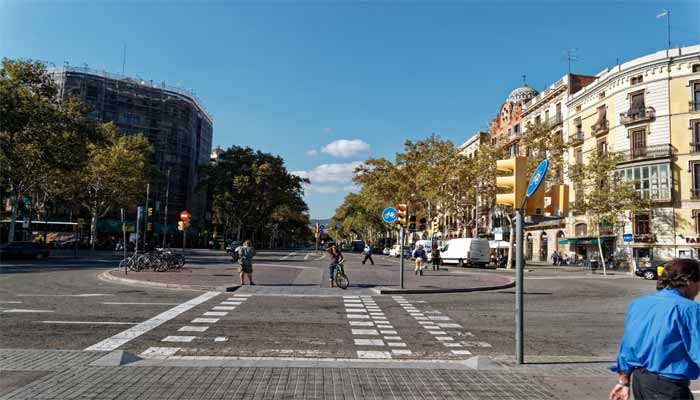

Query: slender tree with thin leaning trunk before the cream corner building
[572,150,650,274]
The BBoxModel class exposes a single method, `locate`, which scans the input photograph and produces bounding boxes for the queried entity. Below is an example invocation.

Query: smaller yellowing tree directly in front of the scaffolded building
[68,122,153,250]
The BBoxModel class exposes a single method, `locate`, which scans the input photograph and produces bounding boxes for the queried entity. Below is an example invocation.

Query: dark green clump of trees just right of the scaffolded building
[201,146,312,247]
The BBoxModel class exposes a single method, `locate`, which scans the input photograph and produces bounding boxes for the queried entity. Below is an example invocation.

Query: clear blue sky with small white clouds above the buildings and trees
[0,0,700,218]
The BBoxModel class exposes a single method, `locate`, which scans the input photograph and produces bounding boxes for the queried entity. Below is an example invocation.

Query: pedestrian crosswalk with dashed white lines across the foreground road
[133,294,491,360]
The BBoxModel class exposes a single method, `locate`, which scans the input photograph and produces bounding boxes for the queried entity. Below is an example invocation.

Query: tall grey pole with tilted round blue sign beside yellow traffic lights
[515,160,549,365]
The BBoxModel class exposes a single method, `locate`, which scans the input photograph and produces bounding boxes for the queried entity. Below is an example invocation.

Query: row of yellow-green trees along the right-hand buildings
[330,123,649,265]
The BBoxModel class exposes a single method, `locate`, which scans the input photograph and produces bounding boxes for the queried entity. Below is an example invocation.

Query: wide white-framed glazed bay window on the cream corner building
[619,164,671,201]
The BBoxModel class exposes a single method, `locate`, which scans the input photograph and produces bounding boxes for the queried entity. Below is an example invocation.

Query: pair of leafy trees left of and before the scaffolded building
[0,59,155,248]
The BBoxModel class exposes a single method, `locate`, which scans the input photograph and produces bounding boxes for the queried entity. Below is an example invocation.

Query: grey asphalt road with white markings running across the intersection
[0,248,654,360]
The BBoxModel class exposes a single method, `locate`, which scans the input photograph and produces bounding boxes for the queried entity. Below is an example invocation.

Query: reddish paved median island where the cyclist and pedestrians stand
[102,252,513,294]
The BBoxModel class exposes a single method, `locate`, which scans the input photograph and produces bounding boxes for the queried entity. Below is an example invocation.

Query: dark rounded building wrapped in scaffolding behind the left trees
[50,66,213,238]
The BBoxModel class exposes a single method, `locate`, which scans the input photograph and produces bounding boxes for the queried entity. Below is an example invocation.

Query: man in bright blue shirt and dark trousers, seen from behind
[609,258,700,400]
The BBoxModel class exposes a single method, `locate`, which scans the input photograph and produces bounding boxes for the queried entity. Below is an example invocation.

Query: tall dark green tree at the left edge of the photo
[0,59,91,241]
